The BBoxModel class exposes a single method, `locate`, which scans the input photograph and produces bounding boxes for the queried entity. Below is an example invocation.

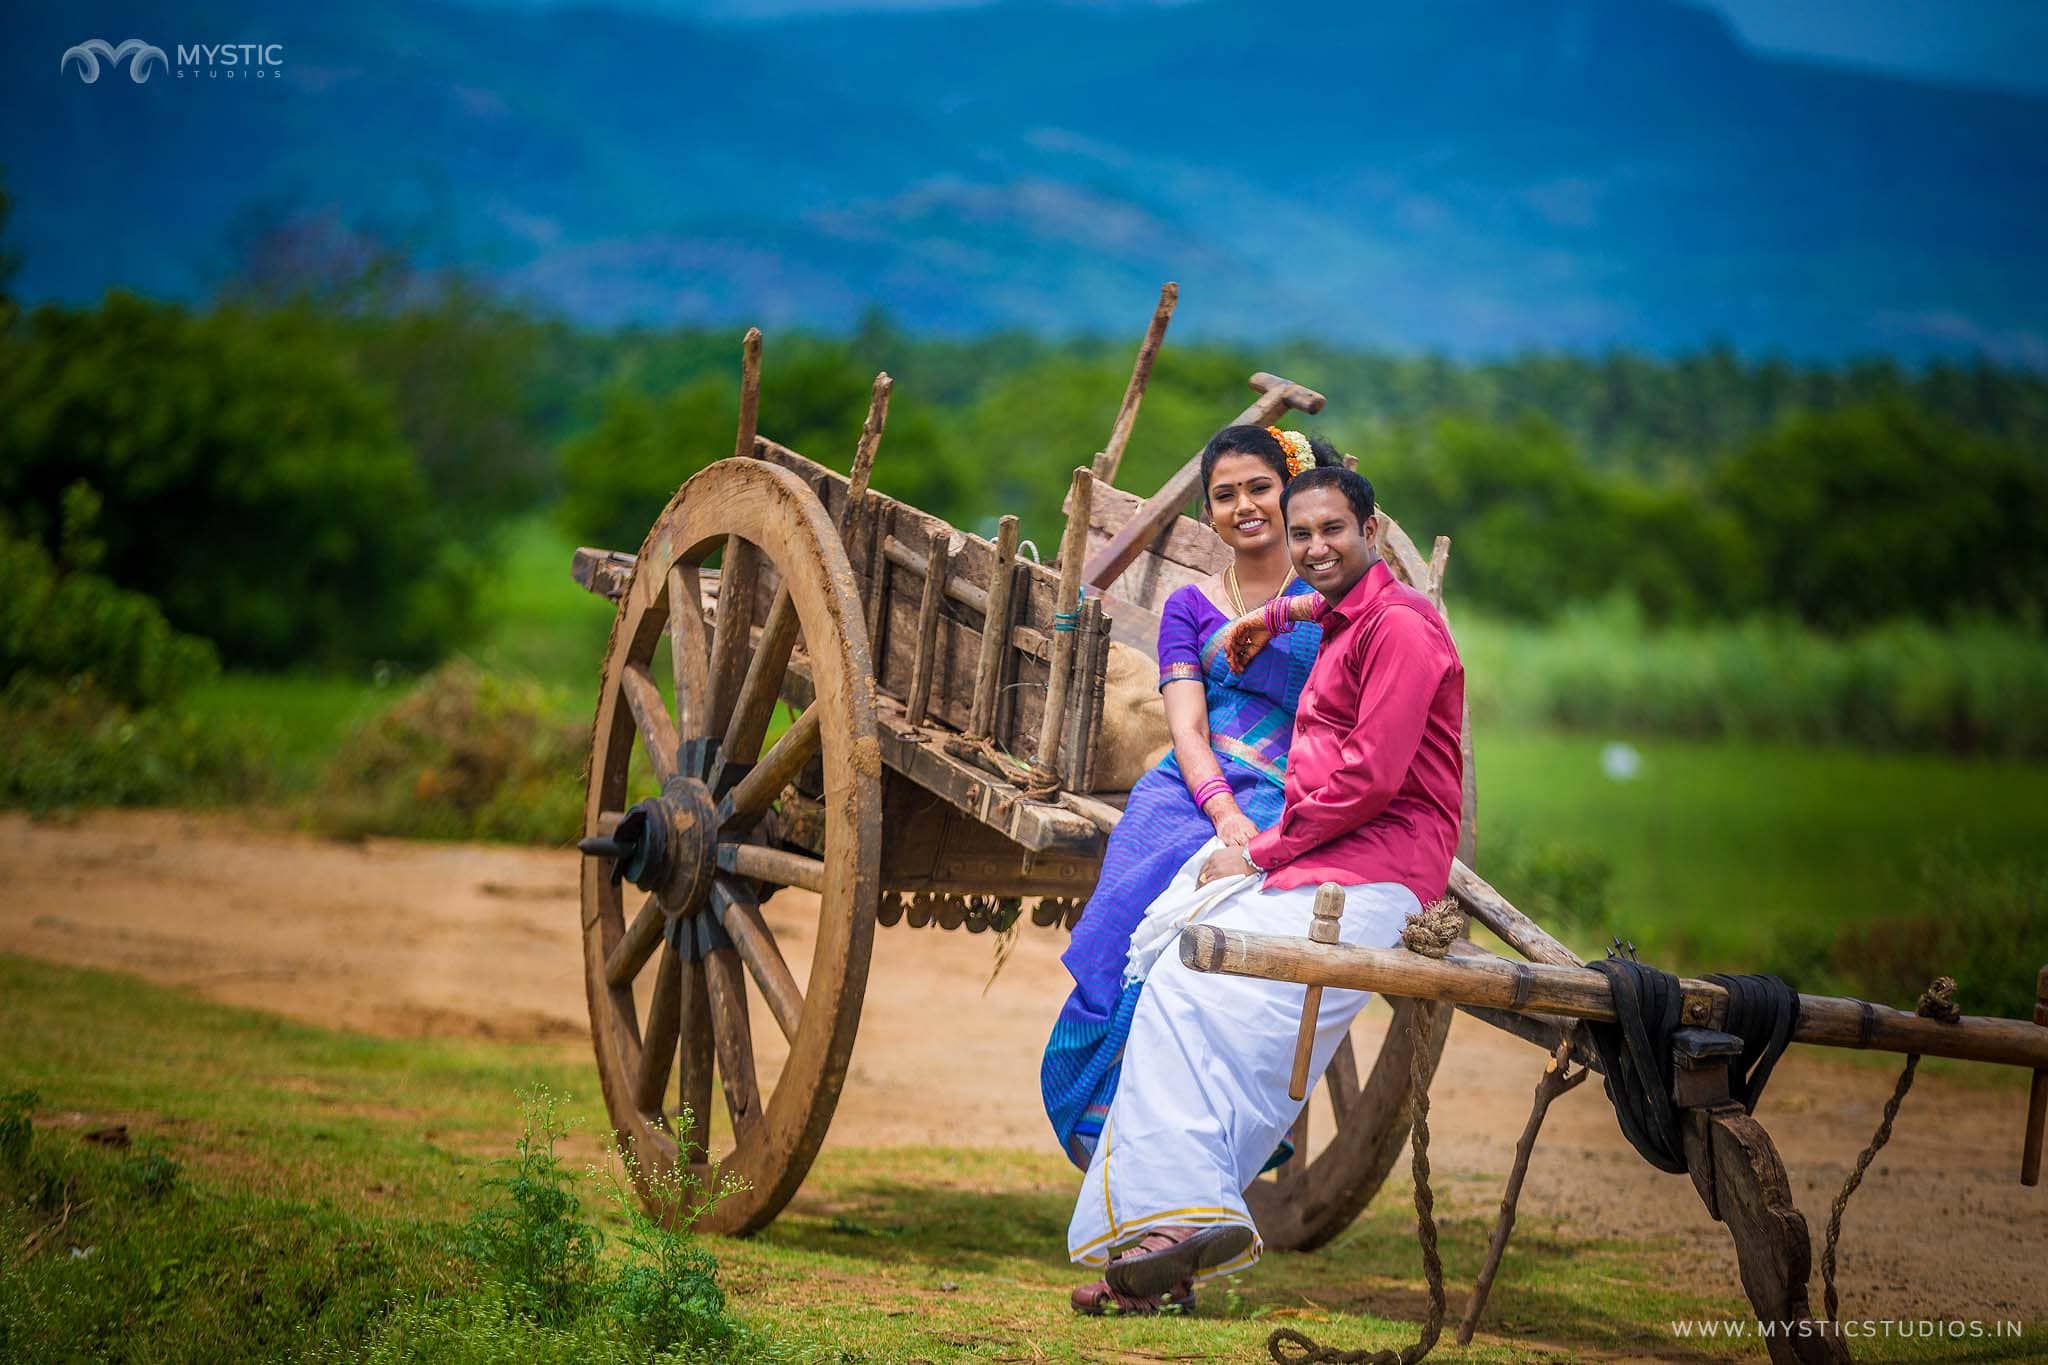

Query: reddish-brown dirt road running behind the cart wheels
[0,812,2048,1322]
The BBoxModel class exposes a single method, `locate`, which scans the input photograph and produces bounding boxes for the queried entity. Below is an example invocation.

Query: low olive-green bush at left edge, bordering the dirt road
[0,675,264,810]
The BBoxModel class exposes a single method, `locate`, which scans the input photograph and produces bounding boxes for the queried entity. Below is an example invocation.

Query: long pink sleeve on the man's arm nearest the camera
[1247,606,1450,872]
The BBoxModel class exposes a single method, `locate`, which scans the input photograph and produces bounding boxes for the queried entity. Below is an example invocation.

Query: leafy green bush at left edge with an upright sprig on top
[0,507,219,706]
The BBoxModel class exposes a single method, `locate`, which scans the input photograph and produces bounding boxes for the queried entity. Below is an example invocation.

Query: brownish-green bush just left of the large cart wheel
[311,659,590,843]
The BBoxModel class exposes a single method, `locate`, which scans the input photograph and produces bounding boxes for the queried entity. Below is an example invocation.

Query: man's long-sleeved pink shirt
[1247,561,1464,905]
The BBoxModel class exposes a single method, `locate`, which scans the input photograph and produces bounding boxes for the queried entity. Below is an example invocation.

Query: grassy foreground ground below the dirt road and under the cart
[12,958,2019,1365]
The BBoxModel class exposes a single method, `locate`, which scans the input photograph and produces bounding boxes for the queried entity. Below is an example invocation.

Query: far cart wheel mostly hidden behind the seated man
[1245,512,1479,1250]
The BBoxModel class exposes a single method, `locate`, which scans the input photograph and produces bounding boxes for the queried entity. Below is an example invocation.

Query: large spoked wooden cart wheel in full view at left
[582,458,881,1232]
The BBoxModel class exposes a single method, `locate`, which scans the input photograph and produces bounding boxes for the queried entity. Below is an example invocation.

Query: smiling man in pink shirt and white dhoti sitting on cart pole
[1067,469,1464,1312]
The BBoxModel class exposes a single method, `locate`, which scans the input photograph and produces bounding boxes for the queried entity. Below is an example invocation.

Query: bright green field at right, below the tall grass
[1475,733,2048,965]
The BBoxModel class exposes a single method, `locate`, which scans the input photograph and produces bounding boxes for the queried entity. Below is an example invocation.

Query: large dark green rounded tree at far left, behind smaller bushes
[0,293,477,667]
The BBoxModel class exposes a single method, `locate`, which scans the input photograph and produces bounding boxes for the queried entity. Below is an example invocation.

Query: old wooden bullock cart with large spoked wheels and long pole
[575,315,2048,1359]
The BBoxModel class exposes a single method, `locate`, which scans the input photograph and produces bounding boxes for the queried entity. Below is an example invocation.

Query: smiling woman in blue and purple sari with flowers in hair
[1038,426,1339,1171]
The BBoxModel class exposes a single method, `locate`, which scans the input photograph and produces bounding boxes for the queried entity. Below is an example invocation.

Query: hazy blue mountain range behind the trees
[12,0,2048,368]
